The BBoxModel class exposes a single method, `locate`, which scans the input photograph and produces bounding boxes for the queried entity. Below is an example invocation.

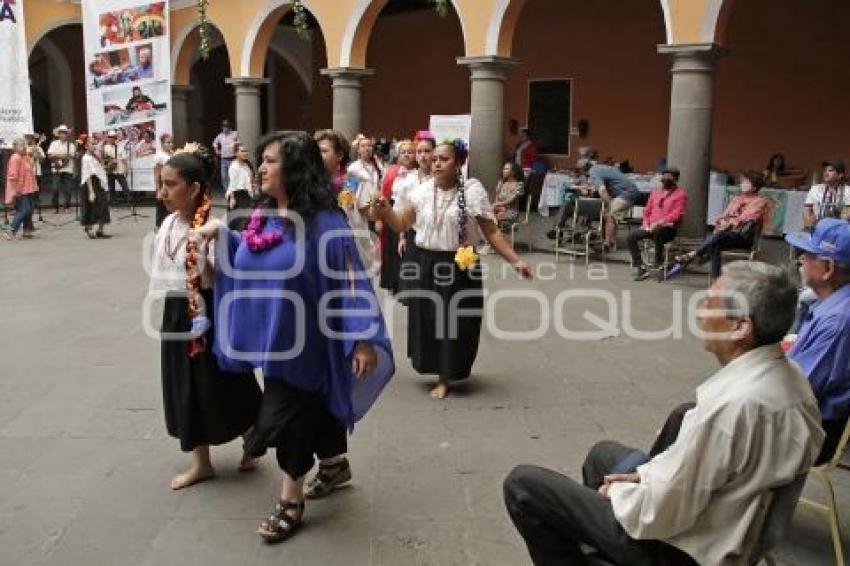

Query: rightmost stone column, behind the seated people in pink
[658,43,726,237]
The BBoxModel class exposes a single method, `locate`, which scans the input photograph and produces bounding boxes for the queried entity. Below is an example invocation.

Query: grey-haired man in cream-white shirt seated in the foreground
[504,262,823,566]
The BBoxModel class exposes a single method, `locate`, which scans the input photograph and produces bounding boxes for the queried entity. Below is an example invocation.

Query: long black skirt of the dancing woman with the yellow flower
[405,248,484,381]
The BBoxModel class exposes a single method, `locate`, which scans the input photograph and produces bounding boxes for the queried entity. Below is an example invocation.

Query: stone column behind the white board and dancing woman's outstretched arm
[457,56,519,198]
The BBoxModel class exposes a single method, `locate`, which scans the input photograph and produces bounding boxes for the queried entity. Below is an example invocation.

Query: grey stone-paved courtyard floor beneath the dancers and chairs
[0,206,850,566]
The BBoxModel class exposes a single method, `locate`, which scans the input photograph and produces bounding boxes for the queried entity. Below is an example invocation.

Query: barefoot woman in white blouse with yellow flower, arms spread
[374,140,532,399]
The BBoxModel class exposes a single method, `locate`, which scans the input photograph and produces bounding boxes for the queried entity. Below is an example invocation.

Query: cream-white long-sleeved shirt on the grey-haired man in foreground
[609,345,824,565]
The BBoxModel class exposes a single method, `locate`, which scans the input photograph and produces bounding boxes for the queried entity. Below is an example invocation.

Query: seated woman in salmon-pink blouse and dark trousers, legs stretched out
[667,171,768,279]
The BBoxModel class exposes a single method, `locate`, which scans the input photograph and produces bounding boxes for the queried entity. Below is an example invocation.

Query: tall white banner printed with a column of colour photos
[83,0,171,191]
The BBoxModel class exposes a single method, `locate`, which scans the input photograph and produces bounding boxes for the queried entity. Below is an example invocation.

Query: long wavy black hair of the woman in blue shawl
[257,131,339,221]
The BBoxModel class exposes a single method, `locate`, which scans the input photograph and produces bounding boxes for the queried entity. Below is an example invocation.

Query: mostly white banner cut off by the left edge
[0,0,32,148]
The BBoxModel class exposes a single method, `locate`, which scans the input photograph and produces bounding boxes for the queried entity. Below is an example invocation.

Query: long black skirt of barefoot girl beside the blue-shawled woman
[162,291,263,452]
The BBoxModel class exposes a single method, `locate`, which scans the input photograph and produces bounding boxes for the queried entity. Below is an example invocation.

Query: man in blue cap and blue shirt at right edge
[785,218,850,464]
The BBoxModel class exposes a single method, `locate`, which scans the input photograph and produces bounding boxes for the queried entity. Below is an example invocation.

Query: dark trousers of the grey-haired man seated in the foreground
[504,404,696,566]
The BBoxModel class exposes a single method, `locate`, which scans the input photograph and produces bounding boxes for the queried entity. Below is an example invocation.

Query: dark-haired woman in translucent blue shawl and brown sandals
[198,132,395,542]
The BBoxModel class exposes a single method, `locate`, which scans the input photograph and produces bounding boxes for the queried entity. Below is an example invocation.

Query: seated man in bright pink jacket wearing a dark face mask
[626,167,688,281]
